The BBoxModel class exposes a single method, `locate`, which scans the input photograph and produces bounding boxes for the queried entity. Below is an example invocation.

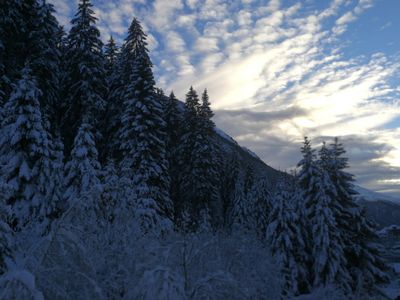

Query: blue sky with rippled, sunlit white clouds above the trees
[49,0,400,199]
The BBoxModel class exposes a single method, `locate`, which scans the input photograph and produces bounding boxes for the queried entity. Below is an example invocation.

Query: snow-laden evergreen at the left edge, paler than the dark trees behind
[0,68,53,228]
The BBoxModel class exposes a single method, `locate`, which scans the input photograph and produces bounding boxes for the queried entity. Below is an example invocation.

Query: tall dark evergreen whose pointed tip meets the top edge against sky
[62,0,107,154]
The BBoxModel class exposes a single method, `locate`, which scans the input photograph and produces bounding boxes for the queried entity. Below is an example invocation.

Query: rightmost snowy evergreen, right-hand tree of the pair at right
[325,138,388,292]
